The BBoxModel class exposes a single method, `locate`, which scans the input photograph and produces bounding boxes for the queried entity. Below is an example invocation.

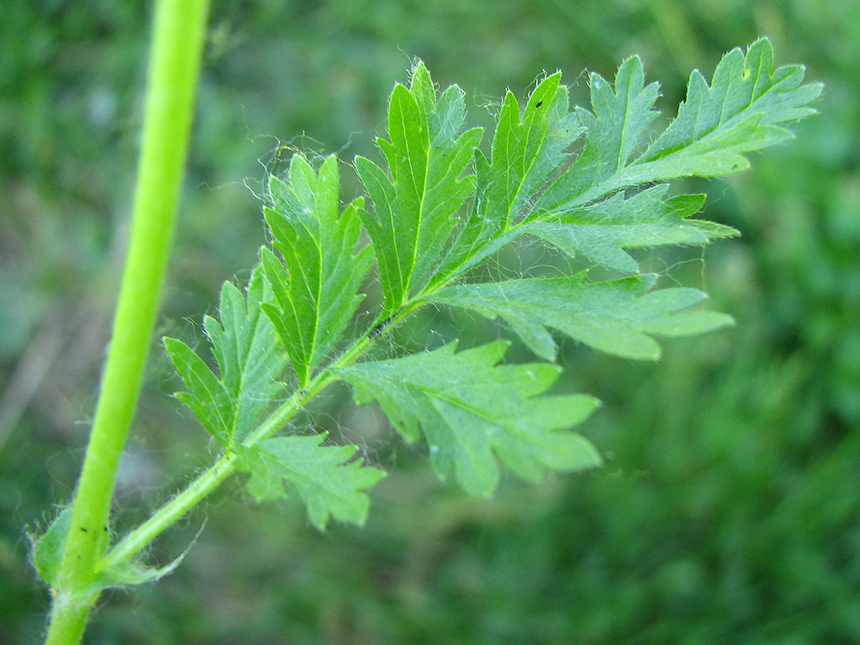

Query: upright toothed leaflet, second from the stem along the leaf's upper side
[261,154,372,386]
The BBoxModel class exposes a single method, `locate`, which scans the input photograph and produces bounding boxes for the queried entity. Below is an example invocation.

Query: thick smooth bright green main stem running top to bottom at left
[47,0,209,644]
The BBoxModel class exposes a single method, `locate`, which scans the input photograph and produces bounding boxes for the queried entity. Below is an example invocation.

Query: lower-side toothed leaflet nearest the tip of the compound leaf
[524,184,738,273]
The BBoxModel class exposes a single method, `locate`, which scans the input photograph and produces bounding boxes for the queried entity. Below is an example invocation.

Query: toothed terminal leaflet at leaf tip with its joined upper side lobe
[538,38,822,211]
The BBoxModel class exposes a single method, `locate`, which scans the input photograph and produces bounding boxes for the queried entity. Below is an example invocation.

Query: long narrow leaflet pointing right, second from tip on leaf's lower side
[430,273,733,360]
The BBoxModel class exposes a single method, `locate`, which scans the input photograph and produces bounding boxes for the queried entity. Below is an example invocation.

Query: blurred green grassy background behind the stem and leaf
[0,0,860,645]
